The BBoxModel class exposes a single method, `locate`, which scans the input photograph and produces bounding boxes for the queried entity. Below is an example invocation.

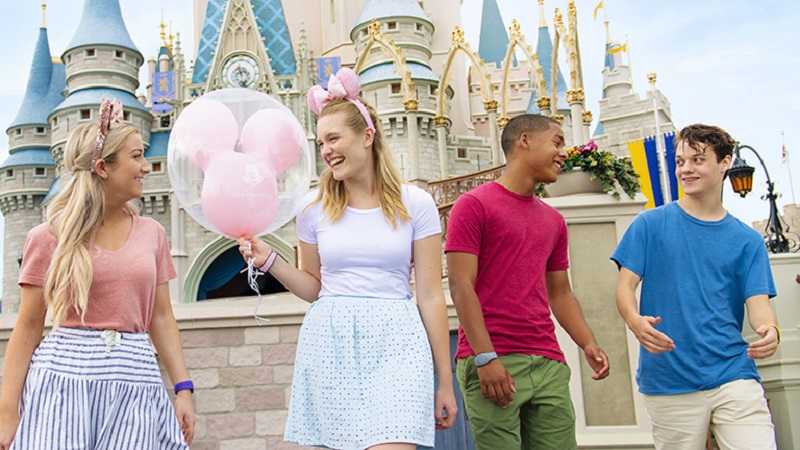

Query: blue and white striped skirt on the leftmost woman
[11,328,189,450]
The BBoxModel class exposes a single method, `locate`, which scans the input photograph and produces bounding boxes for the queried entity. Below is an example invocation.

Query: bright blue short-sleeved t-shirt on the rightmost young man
[611,203,775,395]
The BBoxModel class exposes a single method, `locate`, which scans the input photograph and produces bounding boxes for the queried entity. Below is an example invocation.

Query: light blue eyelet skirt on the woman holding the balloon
[284,297,435,450]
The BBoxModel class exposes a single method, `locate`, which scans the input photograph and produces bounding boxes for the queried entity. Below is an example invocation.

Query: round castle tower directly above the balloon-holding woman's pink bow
[350,0,440,181]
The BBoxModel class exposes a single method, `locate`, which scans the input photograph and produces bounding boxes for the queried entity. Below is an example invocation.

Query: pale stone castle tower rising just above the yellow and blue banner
[592,19,675,156]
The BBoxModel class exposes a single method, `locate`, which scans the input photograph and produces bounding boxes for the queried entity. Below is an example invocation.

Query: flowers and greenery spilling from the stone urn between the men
[537,141,641,200]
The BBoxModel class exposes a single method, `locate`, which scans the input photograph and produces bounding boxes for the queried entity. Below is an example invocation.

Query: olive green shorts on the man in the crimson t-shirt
[456,354,578,450]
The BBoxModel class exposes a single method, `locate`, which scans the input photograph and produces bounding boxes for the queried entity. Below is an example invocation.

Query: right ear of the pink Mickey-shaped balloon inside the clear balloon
[242,109,305,174]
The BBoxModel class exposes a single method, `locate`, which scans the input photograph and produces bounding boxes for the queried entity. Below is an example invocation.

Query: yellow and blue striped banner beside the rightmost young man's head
[627,131,683,209]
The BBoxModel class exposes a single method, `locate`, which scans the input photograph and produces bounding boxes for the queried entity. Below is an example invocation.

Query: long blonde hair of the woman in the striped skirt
[44,123,139,328]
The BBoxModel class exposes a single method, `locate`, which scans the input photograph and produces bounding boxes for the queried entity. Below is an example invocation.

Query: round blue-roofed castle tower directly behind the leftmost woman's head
[50,0,152,175]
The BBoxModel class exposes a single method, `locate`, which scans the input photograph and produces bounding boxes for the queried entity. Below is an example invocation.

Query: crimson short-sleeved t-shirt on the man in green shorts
[445,182,569,364]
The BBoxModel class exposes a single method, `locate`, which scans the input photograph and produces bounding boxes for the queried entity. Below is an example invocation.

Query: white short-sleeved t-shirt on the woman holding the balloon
[297,185,442,299]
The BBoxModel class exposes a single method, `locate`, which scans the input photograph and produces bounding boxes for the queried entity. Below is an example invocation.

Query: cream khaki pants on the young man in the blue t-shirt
[644,379,777,450]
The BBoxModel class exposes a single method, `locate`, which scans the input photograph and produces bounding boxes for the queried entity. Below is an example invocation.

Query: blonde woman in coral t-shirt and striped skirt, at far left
[0,99,194,450]
